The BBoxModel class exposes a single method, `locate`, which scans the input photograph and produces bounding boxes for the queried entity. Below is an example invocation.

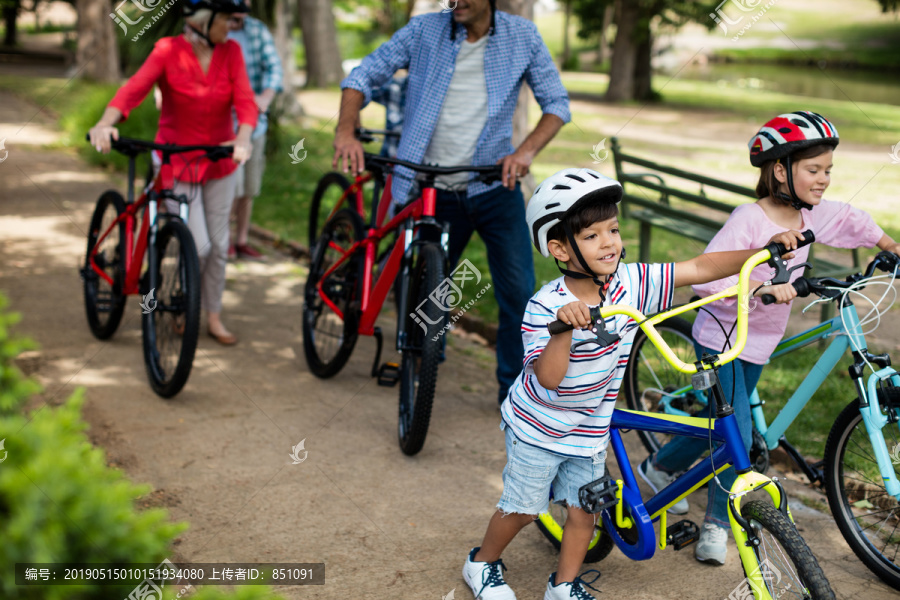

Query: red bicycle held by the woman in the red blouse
[81,138,232,398]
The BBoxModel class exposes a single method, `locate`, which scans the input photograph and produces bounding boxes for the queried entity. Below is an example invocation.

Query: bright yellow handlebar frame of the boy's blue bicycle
[600,250,772,375]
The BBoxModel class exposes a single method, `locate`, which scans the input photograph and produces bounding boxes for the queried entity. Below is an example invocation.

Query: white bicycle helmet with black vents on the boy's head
[525,169,622,258]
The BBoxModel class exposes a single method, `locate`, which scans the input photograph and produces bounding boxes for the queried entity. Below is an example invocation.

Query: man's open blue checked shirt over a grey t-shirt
[341,11,571,201]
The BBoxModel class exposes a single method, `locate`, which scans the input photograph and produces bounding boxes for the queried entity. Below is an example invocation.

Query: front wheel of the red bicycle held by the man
[398,244,447,456]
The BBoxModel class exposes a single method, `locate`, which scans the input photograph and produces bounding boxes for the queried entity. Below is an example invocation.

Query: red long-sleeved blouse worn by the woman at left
[109,35,259,183]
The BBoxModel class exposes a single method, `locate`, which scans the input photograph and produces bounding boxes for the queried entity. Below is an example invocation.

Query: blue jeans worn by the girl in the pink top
[653,342,763,527]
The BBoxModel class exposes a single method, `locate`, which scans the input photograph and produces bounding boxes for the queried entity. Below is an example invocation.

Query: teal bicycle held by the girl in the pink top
[623,252,900,590]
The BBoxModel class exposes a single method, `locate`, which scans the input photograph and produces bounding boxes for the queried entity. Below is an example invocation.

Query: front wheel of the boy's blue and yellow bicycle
[740,500,834,600]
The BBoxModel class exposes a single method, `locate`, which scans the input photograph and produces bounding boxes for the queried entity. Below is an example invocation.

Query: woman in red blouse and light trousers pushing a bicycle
[90,0,259,345]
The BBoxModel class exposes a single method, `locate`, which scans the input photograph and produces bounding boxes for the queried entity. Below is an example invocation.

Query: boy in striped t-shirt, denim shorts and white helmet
[463,169,802,600]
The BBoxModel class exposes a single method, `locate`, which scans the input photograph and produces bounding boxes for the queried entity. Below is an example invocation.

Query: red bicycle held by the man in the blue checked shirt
[303,135,501,455]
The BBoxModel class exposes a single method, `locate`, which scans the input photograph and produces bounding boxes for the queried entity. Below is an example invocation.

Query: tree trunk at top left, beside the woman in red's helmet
[75,0,119,82]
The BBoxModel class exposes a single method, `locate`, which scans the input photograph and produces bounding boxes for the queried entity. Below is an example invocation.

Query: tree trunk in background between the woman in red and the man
[297,0,344,87]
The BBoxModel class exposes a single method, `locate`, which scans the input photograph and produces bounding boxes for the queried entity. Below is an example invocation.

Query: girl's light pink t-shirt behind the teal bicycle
[693,200,884,365]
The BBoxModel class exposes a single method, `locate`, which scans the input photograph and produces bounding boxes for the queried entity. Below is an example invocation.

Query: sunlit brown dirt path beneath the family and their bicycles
[0,85,896,600]
